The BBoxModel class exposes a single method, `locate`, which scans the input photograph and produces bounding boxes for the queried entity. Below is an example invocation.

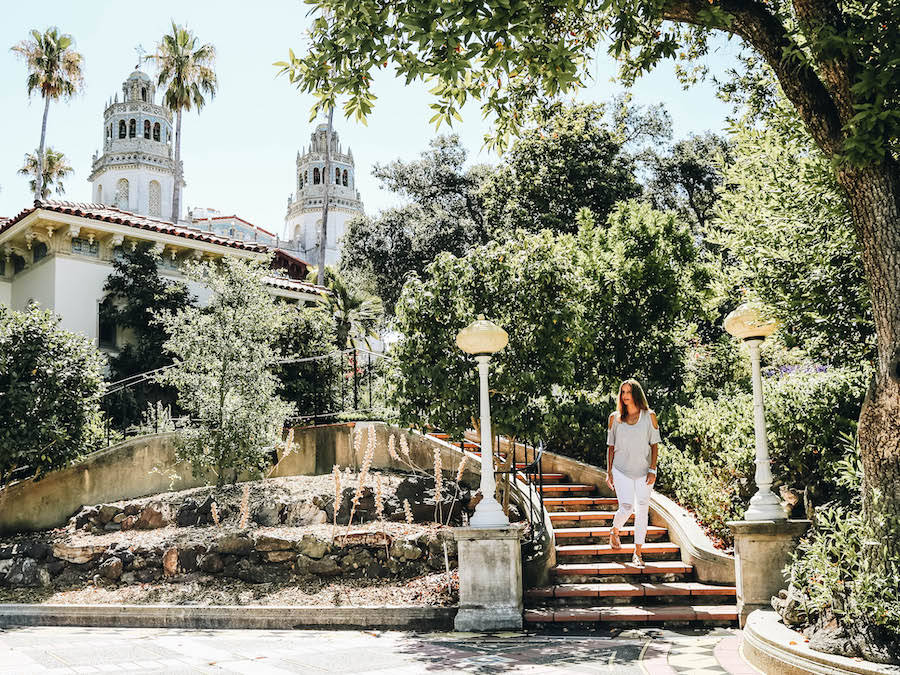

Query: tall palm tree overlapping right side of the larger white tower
[147,21,218,223]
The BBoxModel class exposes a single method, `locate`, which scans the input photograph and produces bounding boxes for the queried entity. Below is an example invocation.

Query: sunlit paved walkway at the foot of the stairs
[0,627,757,675]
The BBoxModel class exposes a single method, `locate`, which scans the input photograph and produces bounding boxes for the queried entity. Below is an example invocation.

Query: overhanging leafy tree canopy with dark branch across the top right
[278,0,900,161]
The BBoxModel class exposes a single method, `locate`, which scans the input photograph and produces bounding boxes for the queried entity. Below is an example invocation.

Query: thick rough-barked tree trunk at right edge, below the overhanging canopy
[838,160,900,555]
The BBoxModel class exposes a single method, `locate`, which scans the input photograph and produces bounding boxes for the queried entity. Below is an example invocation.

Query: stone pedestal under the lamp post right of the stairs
[728,520,810,628]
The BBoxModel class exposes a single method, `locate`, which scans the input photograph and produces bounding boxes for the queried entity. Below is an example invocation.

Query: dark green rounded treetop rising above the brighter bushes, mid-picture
[481,104,641,233]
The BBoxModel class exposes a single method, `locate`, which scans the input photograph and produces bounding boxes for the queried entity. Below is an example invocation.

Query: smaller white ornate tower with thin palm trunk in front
[282,124,363,265]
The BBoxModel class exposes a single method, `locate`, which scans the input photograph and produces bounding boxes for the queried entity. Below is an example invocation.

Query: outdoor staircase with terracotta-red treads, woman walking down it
[523,473,737,625]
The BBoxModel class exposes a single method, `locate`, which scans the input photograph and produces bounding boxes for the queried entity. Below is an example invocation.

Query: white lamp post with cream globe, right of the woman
[725,303,787,520]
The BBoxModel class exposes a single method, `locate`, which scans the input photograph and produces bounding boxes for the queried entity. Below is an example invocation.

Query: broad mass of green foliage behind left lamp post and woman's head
[392,202,705,446]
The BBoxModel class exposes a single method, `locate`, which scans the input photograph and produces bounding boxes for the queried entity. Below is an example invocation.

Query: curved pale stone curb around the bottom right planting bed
[741,609,900,675]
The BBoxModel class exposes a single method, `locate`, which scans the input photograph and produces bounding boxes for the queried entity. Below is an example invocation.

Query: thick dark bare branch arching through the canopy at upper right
[663,0,843,157]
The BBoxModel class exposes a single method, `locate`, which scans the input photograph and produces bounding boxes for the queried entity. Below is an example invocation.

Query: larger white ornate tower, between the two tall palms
[88,67,184,218]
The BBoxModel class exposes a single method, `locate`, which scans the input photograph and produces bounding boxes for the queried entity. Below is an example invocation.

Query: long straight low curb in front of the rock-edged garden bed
[0,604,458,630]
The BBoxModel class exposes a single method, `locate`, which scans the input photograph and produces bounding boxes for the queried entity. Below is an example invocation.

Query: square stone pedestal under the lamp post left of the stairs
[454,526,522,632]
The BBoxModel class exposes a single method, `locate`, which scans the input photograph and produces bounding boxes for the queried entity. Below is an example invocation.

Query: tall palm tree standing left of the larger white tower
[12,26,84,201]
